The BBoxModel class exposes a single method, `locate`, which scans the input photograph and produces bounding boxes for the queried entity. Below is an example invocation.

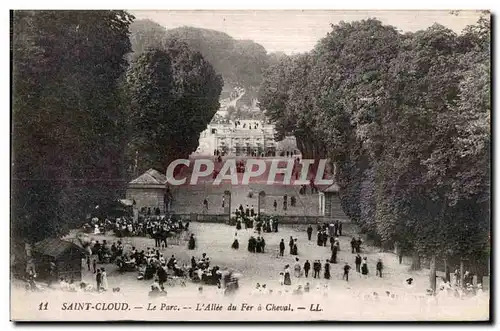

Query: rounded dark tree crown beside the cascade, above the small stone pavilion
[127,40,223,172]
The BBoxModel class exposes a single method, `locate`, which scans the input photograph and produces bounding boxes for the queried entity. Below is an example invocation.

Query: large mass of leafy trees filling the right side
[259,16,491,274]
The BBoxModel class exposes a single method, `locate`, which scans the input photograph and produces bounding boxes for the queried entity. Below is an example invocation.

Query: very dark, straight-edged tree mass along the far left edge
[11,11,133,241]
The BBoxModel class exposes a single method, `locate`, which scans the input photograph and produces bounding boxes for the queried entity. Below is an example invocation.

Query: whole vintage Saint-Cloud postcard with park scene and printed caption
[10,10,491,322]
